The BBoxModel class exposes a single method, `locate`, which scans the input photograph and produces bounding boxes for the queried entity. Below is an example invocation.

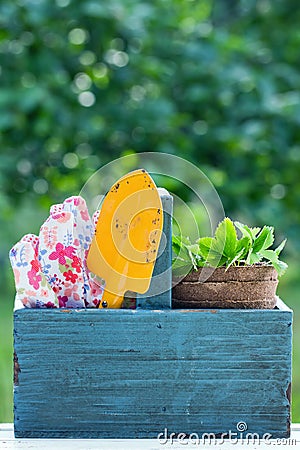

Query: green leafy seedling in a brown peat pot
[172,218,287,309]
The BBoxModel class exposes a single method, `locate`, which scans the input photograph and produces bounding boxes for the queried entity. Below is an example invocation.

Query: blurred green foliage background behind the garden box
[0,0,300,422]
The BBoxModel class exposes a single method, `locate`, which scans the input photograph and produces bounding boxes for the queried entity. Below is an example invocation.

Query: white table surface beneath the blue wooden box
[0,424,300,450]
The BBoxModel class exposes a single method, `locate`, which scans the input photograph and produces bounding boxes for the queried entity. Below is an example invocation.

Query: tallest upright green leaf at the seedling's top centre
[213,217,237,259]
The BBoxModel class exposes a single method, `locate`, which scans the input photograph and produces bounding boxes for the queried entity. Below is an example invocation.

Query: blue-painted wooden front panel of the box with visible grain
[14,304,292,438]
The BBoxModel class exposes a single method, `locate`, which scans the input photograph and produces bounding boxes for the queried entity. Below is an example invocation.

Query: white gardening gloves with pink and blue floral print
[10,197,104,308]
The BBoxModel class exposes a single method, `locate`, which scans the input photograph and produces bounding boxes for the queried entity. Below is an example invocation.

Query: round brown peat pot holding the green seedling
[172,264,278,309]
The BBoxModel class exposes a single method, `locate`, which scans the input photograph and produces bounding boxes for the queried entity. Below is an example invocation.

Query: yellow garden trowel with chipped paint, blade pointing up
[87,169,163,308]
